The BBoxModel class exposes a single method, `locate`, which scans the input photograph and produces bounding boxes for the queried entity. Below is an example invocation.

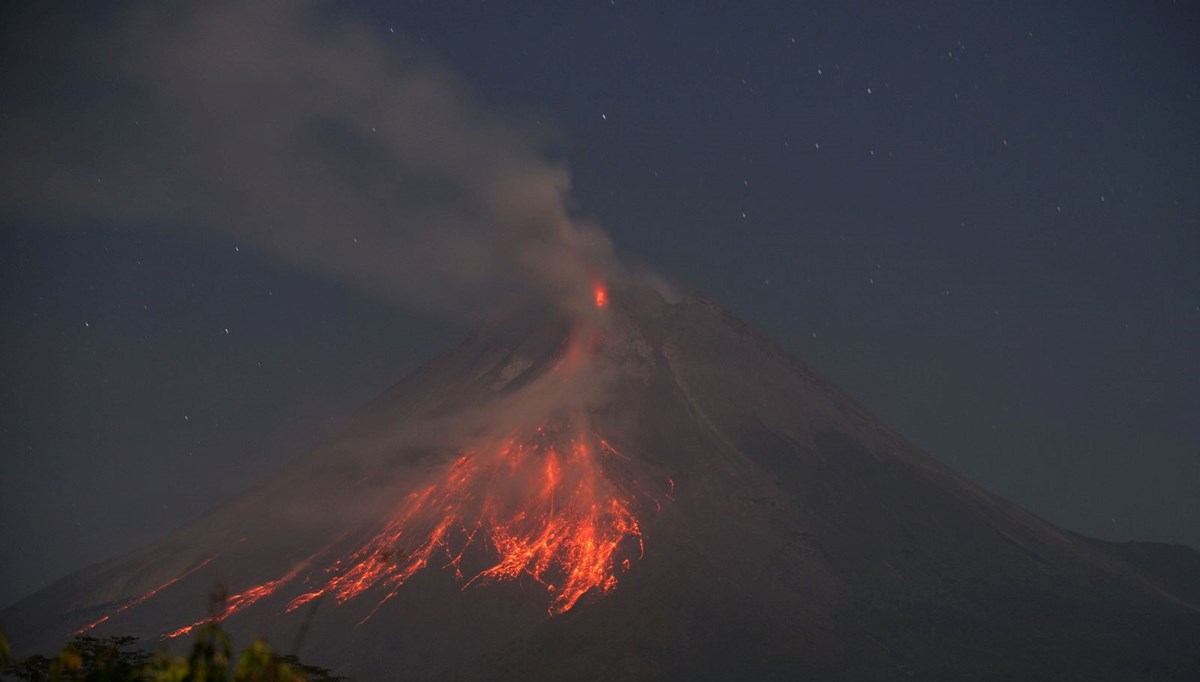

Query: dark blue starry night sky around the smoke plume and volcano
[0,0,1200,603]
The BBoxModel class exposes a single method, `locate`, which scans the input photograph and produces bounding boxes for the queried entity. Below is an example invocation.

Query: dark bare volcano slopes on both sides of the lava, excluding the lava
[5,289,1200,678]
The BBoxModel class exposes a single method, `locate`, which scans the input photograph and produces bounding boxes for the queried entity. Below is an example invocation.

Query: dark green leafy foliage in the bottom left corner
[0,622,346,682]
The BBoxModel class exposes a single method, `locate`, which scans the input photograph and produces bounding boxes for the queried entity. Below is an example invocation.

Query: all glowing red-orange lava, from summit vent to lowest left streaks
[80,289,674,639]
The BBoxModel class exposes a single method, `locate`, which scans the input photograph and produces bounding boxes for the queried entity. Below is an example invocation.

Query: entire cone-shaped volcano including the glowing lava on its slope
[4,288,1200,680]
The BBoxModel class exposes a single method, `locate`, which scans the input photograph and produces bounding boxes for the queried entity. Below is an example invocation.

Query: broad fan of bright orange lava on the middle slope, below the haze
[288,429,642,617]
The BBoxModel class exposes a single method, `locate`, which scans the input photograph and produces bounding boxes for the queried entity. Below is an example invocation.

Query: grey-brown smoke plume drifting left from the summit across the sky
[0,2,614,315]
